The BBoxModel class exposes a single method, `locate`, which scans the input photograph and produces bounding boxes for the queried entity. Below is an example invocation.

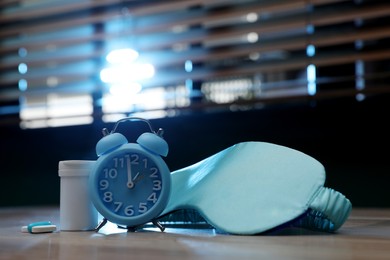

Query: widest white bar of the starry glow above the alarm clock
[100,63,154,84]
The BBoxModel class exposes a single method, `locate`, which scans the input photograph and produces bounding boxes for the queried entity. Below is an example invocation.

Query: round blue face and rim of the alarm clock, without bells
[92,145,170,226]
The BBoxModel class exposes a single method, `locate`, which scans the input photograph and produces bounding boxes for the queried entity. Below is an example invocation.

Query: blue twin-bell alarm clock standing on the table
[88,117,171,231]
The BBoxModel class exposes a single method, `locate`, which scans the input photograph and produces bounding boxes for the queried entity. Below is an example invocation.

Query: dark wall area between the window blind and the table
[0,95,390,207]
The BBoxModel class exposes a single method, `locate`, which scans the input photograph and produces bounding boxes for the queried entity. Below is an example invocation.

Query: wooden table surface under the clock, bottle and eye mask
[0,207,390,260]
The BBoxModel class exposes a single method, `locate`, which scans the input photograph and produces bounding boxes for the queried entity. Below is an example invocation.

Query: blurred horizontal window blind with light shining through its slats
[0,0,390,128]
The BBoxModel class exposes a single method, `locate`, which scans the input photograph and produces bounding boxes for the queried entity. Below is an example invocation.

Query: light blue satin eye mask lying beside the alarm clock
[161,142,352,235]
